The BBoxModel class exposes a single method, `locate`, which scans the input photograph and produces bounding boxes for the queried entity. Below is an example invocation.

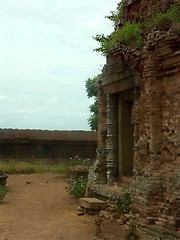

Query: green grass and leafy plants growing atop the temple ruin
[93,1,180,56]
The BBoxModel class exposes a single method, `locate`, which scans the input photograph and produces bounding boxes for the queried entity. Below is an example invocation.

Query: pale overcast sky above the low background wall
[0,0,119,130]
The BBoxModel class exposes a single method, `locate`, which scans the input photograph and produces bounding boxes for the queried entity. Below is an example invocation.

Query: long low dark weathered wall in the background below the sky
[0,129,97,160]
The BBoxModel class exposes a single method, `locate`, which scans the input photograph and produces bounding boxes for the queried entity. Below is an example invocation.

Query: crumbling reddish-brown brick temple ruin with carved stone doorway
[89,0,180,239]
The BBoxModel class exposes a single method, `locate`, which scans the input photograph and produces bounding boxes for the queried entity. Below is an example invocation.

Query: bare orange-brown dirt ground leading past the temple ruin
[0,173,127,240]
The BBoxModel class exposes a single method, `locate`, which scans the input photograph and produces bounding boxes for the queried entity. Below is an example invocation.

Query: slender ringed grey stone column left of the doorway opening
[106,95,117,185]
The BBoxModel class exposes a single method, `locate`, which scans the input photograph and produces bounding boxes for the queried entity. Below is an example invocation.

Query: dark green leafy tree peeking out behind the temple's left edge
[85,77,98,131]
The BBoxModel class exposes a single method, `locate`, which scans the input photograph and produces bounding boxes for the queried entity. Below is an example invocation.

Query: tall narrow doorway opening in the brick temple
[118,97,134,180]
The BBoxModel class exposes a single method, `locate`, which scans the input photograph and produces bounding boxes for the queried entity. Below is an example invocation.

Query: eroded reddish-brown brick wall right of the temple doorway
[132,27,180,231]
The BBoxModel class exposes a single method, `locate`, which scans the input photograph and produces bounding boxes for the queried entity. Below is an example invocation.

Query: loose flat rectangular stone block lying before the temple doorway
[79,198,106,211]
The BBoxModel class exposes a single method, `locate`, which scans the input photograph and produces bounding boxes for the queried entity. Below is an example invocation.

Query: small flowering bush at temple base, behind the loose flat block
[65,177,87,198]
